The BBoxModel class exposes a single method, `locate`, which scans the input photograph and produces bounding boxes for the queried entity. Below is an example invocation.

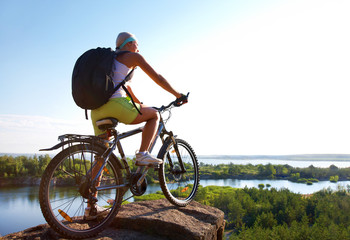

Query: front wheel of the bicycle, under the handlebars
[158,139,200,207]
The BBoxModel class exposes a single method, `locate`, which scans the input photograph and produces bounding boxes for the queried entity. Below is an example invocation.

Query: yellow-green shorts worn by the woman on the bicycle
[91,97,140,136]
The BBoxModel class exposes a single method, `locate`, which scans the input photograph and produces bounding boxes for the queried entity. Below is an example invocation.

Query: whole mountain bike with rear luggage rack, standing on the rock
[39,94,200,239]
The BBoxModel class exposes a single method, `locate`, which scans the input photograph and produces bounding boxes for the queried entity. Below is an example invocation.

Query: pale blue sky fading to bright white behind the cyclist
[0,0,350,155]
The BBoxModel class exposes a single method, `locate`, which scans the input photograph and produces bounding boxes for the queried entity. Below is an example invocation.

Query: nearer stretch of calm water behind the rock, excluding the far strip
[0,179,350,236]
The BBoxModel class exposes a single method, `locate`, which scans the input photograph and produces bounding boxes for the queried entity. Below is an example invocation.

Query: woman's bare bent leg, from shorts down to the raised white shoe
[131,105,159,152]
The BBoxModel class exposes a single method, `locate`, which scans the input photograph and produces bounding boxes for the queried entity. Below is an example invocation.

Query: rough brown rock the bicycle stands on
[1,199,225,240]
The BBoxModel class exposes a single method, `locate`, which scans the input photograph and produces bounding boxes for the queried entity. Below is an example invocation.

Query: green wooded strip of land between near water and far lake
[0,155,350,184]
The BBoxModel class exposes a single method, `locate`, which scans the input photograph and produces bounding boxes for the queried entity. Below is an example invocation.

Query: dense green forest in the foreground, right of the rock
[135,186,350,240]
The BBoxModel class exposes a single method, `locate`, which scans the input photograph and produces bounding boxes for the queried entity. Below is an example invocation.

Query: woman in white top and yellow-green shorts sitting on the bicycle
[91,32,184,166]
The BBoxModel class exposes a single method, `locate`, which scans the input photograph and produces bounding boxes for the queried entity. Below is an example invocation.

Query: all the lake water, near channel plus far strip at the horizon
[0,156,350,236]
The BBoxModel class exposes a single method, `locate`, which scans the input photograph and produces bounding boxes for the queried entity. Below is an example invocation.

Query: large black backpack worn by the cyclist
[72,48,137,119]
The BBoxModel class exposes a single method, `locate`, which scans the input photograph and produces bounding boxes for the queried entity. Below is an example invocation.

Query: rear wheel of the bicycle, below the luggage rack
[39,143,123,239]
